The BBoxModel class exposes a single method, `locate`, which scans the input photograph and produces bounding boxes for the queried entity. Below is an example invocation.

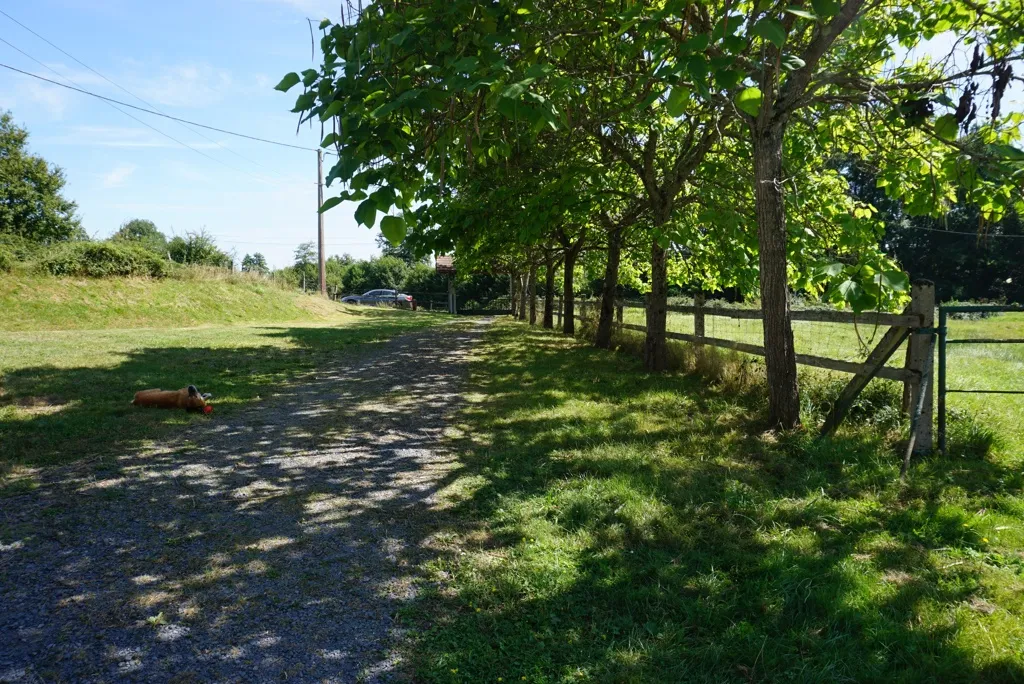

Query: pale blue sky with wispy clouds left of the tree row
[0,0,378,266]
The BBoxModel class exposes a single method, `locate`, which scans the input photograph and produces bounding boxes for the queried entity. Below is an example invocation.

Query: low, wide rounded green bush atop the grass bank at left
[39,242,167,277]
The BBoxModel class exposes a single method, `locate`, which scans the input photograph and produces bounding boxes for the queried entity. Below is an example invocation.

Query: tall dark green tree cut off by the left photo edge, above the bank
[0,112,85,245]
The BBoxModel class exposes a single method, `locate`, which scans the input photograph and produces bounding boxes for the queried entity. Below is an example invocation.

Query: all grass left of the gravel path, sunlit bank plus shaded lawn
[0,275,437,487]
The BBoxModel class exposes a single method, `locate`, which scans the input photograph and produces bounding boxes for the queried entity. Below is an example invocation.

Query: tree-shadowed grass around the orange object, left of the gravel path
[0,309,440,475]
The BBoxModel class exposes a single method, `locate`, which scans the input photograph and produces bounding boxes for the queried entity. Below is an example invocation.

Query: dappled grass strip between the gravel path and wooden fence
[404,324,1024,682]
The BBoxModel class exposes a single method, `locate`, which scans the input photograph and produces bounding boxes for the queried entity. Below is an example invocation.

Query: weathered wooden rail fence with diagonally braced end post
[538,281,935,453]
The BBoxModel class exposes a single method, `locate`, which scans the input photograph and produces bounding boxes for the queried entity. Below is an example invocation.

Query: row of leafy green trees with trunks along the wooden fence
[278,0,1024,428]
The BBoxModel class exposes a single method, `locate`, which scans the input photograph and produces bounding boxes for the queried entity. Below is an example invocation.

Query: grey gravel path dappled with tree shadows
[0,326,480,682]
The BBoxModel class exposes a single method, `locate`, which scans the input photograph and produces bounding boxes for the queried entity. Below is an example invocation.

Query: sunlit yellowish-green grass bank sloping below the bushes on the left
[0,270,348,331]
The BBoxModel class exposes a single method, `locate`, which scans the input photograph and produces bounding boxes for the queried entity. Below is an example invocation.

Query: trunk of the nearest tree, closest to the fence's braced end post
[754,127,800,429]
